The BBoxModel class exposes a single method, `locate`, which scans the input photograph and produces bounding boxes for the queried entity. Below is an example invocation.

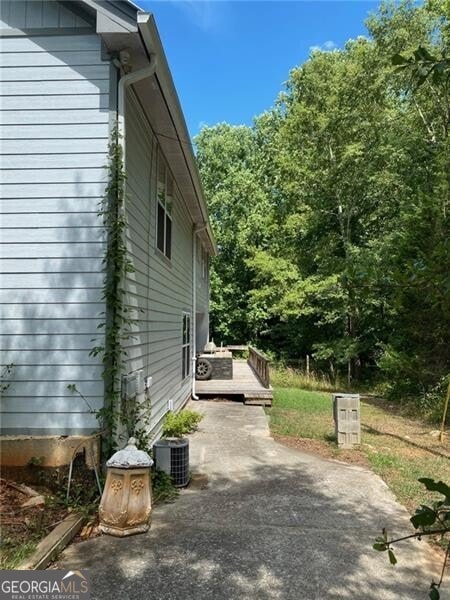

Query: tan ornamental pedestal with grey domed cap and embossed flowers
[99,438,153,537]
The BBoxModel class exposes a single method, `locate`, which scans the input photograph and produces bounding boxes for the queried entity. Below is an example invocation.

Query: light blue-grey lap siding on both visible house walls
[0,0,212,436]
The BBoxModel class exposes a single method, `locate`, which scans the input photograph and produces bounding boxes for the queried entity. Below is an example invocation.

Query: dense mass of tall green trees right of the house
[196,0,450,404]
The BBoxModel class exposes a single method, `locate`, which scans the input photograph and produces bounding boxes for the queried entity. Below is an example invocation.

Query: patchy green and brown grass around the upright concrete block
[267,388,450,511]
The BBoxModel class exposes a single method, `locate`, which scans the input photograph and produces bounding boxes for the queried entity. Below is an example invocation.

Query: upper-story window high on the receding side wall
[156,154,174,259]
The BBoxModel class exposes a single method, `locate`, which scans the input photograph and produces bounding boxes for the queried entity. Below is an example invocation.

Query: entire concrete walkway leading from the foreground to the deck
[59,401,447,600]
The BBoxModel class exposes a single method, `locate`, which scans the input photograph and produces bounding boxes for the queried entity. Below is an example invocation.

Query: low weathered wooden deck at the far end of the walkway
[195,359,273,406]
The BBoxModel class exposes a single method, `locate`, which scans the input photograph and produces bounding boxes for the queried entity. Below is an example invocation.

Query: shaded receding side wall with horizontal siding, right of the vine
[125,90,193,432]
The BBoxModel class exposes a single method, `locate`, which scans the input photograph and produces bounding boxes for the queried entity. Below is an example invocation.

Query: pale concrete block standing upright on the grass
[332,394,361,448]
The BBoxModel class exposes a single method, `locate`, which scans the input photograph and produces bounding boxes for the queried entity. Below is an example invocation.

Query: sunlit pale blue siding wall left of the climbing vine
[0,9,112,435]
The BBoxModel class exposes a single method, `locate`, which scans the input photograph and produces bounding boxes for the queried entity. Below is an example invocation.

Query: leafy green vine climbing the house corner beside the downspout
[67,125,152,458]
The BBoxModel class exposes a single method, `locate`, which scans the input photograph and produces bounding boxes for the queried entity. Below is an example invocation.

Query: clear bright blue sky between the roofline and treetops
[135,0,379,136]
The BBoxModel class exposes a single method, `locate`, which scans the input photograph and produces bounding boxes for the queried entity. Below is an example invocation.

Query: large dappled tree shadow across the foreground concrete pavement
[61,459,431,600]
